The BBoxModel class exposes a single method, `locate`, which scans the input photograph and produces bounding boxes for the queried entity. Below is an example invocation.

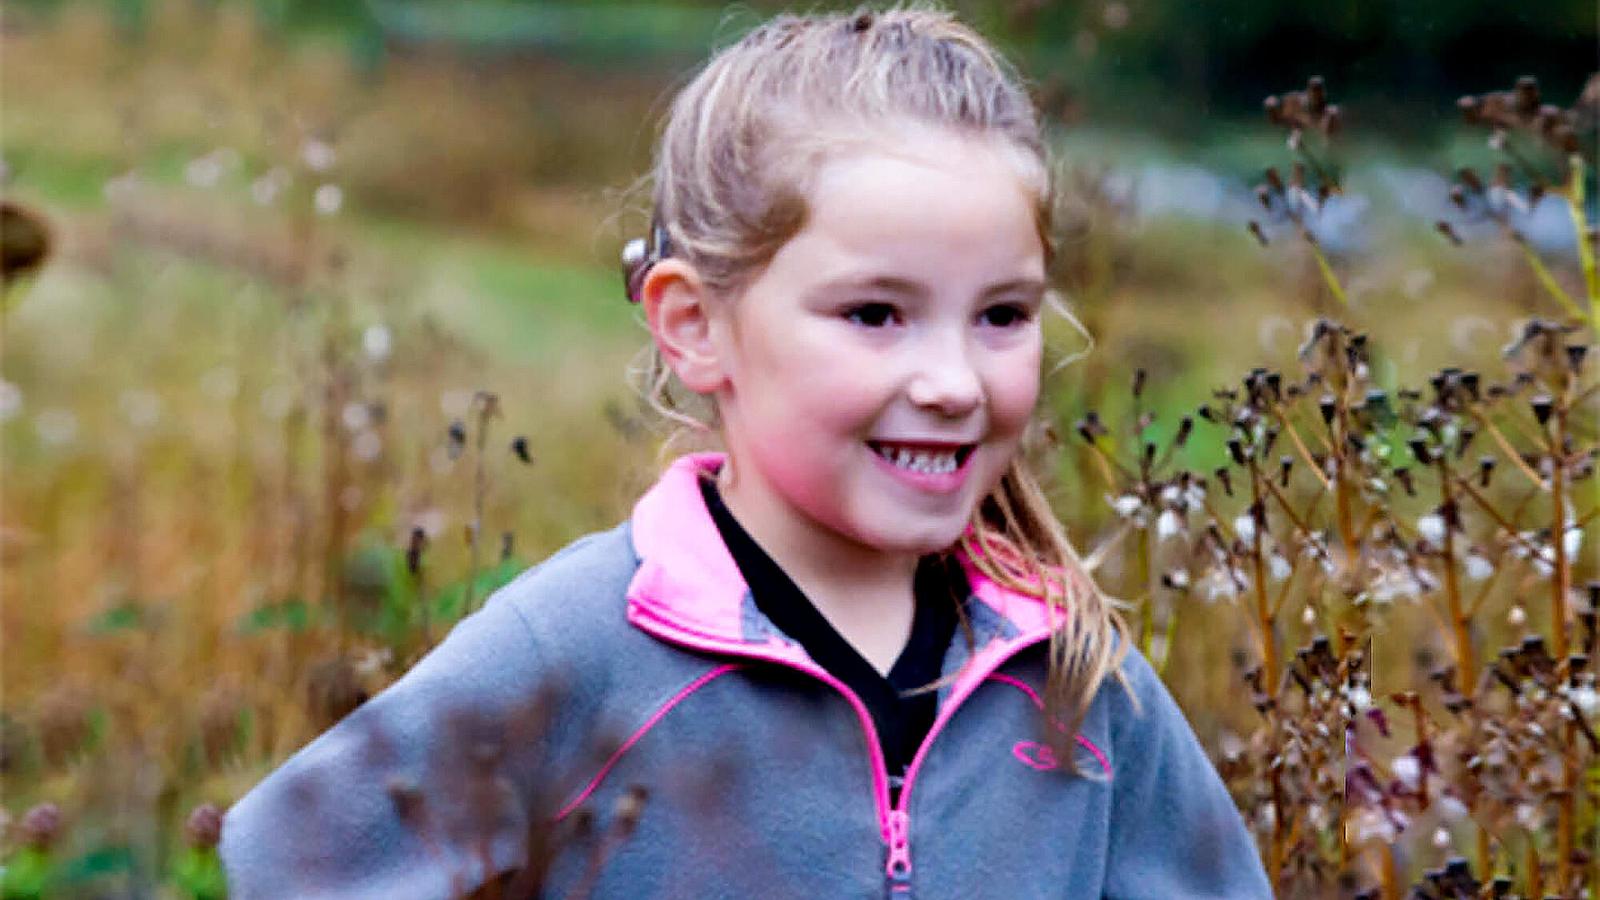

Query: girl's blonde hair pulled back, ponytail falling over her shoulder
[635,5,1131,772]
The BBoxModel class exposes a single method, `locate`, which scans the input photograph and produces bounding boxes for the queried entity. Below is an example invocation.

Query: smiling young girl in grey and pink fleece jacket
[222,10,1270,900]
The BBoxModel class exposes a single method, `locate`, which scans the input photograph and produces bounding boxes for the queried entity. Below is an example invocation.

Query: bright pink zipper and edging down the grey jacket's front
[627,604,1048,897]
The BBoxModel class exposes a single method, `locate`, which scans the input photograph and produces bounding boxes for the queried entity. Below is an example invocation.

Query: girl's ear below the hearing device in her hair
[640,256,726,394]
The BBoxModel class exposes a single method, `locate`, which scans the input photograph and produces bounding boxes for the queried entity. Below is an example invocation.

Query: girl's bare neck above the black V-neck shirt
[717,466,918,674]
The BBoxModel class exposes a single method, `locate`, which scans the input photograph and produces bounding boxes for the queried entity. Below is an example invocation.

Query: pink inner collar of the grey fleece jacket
[627,453,1050,644]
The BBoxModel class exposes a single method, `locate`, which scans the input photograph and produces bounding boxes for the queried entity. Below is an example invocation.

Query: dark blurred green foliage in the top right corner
[990,0,1600,128]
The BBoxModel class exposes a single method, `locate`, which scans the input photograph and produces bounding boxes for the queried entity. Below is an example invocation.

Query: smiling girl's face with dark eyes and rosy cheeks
[717,130,1045,556]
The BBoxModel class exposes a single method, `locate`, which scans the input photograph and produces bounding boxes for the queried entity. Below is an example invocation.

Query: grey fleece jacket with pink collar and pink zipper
[221,453,1270,900]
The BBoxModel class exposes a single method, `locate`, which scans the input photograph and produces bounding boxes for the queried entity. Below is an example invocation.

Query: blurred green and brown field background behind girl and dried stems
[0,0,1600,897]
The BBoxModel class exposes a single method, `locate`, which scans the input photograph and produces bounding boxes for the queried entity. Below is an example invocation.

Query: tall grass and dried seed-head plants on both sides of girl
[0,3,1600,897]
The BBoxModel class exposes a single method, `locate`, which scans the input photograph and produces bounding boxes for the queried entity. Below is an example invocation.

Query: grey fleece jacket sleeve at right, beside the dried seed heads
[1106,649,1272,900]
